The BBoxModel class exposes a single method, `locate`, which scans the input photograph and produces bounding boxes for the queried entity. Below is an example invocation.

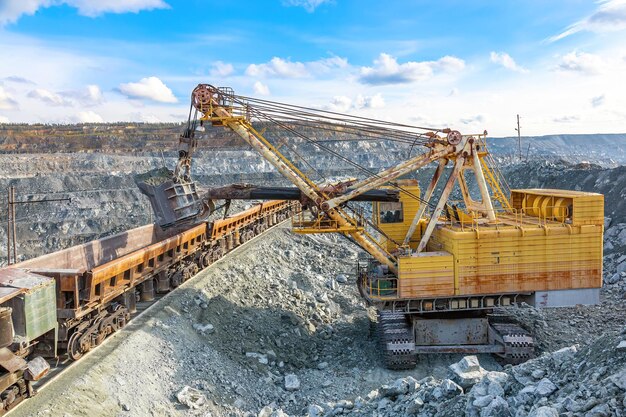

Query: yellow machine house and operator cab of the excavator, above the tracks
[368,183,604,300]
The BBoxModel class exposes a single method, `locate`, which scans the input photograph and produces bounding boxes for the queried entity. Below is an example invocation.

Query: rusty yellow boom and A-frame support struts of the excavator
[179,84,493,274]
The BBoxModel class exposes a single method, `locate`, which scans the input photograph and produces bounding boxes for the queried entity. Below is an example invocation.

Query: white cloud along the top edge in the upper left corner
[0,0,169,26]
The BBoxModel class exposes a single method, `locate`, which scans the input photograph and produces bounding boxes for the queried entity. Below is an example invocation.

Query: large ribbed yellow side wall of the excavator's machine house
[429,223,602,295]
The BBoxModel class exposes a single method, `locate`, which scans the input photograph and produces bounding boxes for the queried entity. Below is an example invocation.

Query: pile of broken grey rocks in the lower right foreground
[292,328,626,417]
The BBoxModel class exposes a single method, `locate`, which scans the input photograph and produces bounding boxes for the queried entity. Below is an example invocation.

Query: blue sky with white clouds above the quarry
[0,0,626,135]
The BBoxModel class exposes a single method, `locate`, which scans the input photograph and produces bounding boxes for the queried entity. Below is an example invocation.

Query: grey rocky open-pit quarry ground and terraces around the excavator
[0,127,626,417]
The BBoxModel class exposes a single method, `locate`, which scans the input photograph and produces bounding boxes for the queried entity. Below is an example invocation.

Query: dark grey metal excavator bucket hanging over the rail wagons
[135,168,210,228]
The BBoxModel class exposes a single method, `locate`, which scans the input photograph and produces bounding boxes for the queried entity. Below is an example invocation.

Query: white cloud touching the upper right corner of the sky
[548,0,626,42]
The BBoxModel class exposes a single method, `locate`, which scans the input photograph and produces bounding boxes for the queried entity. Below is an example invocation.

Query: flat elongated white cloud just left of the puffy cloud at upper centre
[246,57,348,78]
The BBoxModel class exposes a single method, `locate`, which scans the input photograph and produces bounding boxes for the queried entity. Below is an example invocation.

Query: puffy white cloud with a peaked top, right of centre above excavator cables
[359,53,465,85]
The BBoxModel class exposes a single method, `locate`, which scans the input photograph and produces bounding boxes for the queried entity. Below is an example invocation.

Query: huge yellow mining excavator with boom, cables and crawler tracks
[139,84,604,369]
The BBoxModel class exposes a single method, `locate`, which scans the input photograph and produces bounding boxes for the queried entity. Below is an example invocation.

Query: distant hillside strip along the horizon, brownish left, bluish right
[0,123,626,166]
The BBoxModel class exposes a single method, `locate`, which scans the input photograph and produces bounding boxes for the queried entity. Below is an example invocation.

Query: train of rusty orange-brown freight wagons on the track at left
[0,201,299,414]
